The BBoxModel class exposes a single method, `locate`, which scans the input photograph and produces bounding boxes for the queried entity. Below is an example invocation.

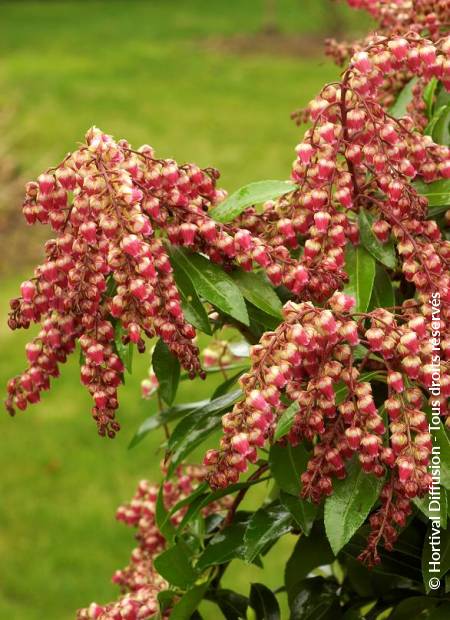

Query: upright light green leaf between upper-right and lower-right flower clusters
[344,245,375,312]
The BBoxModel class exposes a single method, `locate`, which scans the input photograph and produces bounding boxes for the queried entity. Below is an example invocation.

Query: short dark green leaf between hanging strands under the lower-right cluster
[269,443,310,496]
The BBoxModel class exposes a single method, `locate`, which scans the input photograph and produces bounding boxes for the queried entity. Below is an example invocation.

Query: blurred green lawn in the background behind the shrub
[0,0,368,620]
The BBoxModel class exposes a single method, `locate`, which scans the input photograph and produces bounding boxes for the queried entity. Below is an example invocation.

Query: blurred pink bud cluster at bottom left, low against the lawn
[77,466,230,620]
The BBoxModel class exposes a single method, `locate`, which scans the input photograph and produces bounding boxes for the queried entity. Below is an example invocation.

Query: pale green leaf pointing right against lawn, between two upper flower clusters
[209,181,298,224]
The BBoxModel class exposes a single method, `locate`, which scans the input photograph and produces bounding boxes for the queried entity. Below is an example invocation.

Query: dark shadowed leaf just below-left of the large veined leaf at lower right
[284,527,334,601]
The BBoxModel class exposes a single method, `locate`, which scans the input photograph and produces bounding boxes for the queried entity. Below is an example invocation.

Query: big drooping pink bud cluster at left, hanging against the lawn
[6,128,318,436]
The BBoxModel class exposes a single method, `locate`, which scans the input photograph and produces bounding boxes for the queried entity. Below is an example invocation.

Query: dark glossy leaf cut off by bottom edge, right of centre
[290,577,342,620]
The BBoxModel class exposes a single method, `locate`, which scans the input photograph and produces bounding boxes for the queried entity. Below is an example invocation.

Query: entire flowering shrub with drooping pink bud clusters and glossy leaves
[6,0,450,620]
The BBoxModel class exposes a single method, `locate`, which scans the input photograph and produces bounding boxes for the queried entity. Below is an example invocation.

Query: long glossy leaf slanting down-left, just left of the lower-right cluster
[168,390,242,475]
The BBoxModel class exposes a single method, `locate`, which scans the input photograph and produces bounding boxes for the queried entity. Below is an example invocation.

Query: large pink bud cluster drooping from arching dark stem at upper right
[268,34,450,306]
